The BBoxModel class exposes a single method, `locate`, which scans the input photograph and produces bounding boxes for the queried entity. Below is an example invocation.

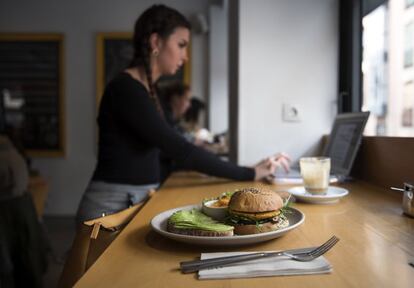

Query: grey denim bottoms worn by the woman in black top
[76,181,159,224]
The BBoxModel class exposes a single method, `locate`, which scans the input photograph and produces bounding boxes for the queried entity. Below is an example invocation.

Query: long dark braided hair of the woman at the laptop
[129,5,191,116]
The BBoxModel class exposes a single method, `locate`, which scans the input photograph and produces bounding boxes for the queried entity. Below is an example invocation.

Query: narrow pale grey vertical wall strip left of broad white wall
[208,3,229,133]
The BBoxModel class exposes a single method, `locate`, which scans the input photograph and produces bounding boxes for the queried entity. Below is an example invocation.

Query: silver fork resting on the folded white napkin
[180,236,339,273]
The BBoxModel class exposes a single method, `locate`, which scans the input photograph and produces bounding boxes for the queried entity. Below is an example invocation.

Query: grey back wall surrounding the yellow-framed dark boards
[0,0,210,214]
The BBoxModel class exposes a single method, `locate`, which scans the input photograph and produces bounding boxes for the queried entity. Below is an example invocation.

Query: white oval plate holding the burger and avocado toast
[151,205,305,246]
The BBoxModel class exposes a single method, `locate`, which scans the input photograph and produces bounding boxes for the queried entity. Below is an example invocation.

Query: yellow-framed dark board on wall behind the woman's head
[96,32,191,107]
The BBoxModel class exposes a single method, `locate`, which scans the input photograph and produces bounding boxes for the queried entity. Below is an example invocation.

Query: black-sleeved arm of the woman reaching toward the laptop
[112,79,255,180]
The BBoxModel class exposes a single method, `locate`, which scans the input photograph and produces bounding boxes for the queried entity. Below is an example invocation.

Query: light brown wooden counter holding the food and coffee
[76,173,414,288]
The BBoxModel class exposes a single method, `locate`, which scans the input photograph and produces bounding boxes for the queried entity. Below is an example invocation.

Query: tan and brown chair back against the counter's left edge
[58,190,154,287]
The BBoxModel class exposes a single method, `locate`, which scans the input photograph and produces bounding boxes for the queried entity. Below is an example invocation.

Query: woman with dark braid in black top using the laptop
[77,5,288,222]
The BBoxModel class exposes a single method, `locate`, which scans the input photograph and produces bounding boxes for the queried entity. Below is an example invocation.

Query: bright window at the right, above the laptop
[361,0,414,137]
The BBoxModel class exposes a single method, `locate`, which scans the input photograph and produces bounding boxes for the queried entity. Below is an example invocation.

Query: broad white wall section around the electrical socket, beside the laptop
[238,0,338,164]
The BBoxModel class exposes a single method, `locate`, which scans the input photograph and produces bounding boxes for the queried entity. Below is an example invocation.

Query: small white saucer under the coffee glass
[288,186,348,204]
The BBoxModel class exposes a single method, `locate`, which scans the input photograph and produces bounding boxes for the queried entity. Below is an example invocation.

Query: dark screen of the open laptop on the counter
[323,112,369,176]
